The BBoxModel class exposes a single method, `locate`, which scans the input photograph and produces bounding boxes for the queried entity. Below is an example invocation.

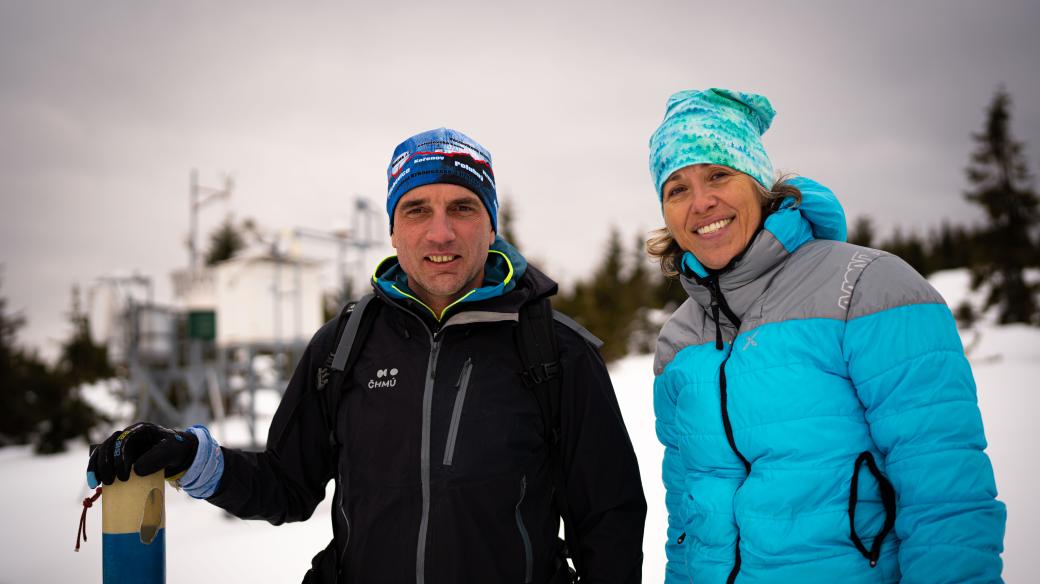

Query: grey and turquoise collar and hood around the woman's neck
[679,177,847,319]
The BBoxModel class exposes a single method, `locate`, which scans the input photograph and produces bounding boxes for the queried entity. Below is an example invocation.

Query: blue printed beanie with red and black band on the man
[387,128,498,234]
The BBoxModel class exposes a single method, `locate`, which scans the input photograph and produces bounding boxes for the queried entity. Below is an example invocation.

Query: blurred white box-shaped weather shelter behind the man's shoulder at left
[211,255,323,347]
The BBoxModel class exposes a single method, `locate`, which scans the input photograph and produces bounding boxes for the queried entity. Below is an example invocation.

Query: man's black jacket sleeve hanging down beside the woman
[557,327,647,584]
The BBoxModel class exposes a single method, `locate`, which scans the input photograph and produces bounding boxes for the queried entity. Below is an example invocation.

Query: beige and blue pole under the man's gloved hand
[101,471,166,584]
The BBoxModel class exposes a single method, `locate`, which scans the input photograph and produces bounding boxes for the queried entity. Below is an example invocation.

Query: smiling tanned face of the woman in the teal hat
[661,164,762,269]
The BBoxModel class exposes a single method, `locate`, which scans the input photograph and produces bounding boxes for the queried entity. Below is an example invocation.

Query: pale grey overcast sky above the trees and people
[0,0,1040,353]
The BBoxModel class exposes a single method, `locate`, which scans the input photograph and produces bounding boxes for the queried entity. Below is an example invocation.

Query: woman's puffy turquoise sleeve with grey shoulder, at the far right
[842,255,1006,584]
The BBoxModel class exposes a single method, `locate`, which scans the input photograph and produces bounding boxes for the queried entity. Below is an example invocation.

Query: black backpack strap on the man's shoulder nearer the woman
[517,298,595,579]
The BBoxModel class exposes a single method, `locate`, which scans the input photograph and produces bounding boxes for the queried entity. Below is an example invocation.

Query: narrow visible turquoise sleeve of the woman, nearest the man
[653,361,690,584]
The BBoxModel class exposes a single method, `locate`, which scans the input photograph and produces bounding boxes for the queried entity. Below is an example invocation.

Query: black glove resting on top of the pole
[86,422,199,488]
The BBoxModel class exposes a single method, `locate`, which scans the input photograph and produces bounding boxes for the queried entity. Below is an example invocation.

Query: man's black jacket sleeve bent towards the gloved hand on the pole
[208,321,335,525]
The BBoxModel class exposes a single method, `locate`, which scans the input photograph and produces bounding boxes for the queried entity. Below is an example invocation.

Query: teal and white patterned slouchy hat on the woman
[650,88,776,198]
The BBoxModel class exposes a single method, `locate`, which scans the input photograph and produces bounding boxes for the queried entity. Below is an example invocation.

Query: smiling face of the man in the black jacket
[390,184,495,314]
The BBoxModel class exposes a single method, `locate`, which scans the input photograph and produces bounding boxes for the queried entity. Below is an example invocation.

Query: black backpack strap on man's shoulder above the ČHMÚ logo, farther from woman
[316,294,379,448]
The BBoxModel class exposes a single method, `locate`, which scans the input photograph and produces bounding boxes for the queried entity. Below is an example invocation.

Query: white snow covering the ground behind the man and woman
[0,271,1040,584]
